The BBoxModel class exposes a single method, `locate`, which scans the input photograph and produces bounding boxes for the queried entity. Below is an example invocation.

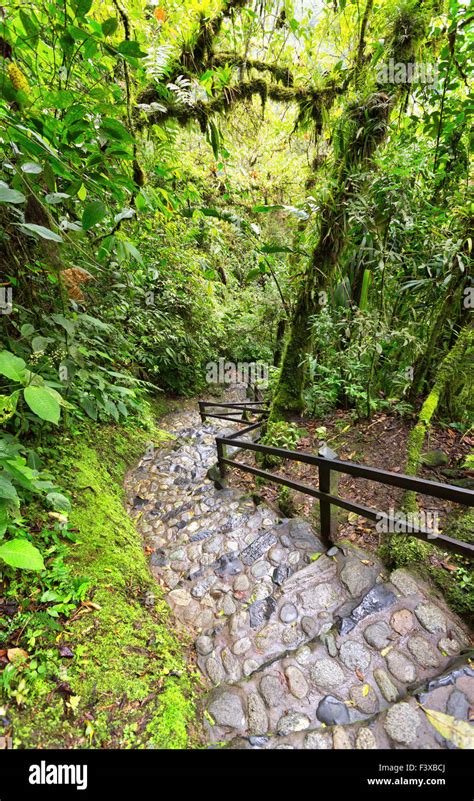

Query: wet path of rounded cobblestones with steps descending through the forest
[126,387,474,748]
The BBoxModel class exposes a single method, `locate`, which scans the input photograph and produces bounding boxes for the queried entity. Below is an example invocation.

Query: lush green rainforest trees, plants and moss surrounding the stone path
[0,0,474,747]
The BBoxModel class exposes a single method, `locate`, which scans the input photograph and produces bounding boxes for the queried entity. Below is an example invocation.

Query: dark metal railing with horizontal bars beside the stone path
[199,401,474,558]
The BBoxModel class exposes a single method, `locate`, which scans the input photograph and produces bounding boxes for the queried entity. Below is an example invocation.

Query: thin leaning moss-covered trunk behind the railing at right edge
[403,326,474,512]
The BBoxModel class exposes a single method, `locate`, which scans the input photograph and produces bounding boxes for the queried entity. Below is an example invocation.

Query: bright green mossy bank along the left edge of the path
[10,406,202,748]
